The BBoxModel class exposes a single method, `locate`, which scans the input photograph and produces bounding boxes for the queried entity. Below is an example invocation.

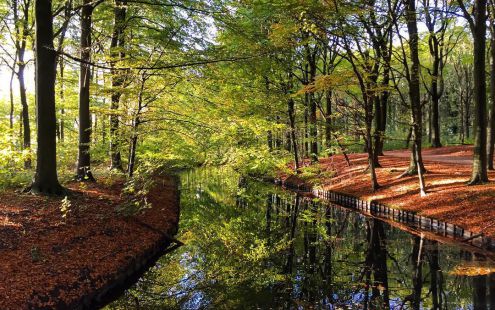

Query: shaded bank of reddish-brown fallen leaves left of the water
[0,177,179,309]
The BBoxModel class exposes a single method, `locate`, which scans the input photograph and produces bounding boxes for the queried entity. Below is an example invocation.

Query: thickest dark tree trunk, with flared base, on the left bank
[31,0,64,195]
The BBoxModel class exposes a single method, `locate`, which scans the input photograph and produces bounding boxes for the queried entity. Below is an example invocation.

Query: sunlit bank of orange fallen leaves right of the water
[282,146,495,237]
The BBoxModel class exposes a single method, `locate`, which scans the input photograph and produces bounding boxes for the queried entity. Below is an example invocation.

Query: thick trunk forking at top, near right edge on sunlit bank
[457,0,488,185]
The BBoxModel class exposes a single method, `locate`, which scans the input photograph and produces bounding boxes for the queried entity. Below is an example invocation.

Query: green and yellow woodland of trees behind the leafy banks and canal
[1,0,488,193]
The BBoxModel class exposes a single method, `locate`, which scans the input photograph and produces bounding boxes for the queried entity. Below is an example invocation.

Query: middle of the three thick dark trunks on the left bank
[76,0,95,181]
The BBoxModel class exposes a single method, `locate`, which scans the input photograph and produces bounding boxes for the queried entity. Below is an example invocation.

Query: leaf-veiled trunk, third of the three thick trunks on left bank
[110,0,127,171]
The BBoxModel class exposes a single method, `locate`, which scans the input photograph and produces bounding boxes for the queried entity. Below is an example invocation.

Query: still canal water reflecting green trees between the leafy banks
[108,169,495,309]
